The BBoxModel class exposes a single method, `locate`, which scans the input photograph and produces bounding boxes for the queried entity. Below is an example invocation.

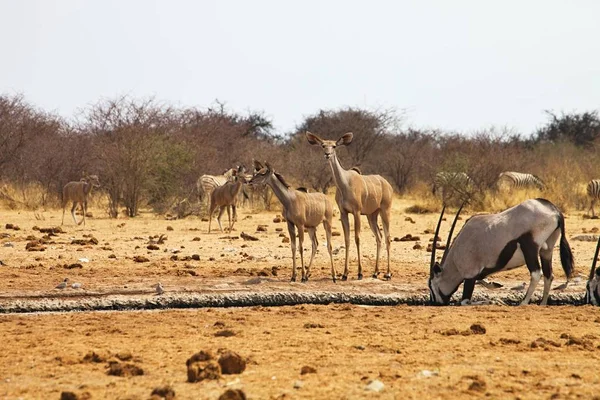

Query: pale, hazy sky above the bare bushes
[0,0,600,134]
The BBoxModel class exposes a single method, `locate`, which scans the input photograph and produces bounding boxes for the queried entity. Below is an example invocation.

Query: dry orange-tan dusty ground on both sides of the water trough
[0,199,600,399]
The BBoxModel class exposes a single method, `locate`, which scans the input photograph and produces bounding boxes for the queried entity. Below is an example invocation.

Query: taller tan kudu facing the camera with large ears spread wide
[306,132,394,281]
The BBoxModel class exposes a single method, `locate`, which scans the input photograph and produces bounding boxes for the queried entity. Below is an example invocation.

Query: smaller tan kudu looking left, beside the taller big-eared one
[250,161,336,282]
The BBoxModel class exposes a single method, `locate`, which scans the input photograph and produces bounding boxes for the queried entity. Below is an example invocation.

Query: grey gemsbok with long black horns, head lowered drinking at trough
[428,199,573,305]
